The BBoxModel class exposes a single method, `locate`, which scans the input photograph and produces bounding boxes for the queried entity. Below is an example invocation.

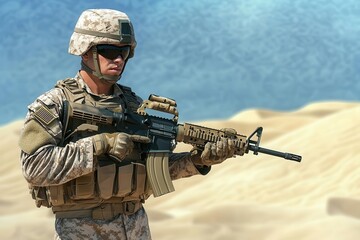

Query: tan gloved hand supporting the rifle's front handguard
[190,128,237,166]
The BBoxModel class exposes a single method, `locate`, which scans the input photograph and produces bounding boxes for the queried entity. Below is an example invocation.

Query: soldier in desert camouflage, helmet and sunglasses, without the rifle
[19,9,234,239]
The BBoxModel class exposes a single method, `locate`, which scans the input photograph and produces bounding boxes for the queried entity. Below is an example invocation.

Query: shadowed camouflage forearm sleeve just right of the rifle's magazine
[169,152,211,180]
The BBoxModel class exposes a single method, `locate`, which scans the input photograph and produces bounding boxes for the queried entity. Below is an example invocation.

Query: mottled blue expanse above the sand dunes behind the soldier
[0,0,360,124]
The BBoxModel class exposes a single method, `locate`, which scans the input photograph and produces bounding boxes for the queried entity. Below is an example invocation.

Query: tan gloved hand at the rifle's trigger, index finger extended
[92,133,150,161]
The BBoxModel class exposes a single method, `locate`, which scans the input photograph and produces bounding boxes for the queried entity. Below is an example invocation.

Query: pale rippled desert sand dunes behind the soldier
[0,102,360,240]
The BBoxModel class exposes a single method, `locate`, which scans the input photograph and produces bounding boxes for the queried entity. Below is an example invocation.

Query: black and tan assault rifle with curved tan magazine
[64,95,301,197]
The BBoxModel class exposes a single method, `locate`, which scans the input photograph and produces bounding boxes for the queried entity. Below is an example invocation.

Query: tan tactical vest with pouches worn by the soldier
[33,79,151,219]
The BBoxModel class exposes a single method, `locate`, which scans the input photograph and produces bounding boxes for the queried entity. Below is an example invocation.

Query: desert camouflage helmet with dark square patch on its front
[69,9,136,58]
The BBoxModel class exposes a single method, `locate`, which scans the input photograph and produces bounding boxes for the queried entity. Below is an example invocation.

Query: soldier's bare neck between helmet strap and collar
[80,70,113,95]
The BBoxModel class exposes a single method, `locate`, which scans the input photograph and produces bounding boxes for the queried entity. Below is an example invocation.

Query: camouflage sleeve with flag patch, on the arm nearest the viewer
[19,88,94,186]
